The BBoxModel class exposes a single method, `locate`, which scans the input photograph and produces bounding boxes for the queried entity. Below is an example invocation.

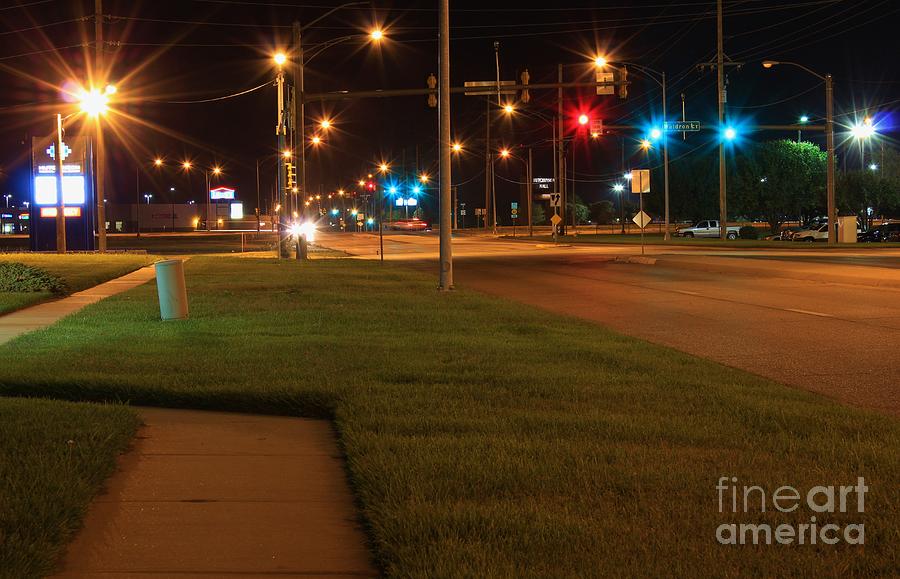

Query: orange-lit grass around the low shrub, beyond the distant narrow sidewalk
[0,253,156,314]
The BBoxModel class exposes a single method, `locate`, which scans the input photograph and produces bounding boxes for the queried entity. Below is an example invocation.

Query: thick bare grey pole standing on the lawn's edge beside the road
[438,0,454,291]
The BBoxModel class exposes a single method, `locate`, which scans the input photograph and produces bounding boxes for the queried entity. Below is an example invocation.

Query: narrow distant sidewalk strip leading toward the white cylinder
[0,265,156,344]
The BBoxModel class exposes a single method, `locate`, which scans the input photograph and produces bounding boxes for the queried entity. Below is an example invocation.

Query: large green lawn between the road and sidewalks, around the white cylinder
[0,257,900,577]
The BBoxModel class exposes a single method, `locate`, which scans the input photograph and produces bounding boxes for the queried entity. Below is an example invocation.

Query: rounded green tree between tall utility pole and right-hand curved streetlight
[728,140,826,233]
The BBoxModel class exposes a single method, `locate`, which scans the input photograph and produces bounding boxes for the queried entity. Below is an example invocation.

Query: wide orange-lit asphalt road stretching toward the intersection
[320,234,900,415]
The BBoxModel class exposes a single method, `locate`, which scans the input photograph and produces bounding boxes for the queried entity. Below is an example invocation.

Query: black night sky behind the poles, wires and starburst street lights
[0,0,900,221]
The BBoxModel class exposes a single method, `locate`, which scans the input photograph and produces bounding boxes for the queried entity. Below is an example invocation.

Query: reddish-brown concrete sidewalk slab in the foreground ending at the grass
[57,408,378,578]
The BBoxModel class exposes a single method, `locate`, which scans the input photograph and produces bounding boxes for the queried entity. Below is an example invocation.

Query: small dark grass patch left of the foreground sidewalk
[0,398,138,579]
